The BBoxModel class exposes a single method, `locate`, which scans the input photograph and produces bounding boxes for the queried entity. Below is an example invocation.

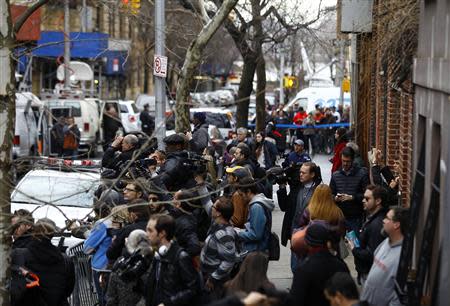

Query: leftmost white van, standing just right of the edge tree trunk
[13,92,43,158]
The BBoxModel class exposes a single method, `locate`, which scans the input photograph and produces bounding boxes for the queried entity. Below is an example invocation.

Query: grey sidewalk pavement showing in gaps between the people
[267,154,356,290]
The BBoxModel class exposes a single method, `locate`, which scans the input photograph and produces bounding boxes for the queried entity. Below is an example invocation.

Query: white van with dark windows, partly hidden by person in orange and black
[45,98,99,154]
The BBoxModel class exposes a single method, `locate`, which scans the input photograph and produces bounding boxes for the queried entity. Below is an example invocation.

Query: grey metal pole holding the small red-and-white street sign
[155,0,166,149]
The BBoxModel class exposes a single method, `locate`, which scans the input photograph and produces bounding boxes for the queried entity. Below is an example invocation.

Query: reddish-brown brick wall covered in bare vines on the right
[356,0,417,205]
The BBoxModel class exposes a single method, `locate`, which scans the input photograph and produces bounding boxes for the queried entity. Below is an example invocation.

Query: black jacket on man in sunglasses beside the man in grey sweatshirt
[352,208,387,274]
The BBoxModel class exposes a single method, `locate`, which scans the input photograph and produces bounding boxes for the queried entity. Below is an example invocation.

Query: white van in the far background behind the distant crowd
[284,87,351,113]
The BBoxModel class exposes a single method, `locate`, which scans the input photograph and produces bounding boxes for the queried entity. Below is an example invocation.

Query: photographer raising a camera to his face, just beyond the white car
[102,134,139,171]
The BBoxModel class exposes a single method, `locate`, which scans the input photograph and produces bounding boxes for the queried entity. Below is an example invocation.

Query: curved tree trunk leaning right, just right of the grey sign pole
[175,0,238,133]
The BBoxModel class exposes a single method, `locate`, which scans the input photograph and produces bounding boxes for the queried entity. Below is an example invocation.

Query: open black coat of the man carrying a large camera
[277,184,316,246]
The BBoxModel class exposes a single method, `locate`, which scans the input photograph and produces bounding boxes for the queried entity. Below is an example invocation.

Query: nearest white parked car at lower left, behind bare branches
[11,169,100,228]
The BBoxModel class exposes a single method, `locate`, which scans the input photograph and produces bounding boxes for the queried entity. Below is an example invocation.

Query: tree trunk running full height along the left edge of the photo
[0,0,15,306]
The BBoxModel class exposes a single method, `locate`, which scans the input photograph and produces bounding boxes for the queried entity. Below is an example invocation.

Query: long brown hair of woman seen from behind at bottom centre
[225,252,275,295]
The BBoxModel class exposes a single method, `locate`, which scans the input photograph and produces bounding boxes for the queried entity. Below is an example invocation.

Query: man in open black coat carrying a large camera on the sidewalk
[277,162,322,271]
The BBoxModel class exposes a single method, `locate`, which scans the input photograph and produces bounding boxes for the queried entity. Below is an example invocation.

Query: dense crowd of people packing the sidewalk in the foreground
[11,110,409,306]
